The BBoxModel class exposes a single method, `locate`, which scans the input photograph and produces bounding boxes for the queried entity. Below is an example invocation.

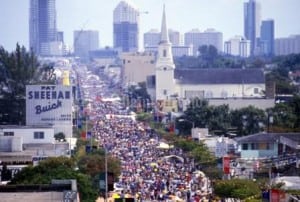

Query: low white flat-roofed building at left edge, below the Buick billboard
[0,125,71,166]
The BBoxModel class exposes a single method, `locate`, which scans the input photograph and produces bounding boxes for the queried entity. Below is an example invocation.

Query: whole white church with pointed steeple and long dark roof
[147,8,274,112]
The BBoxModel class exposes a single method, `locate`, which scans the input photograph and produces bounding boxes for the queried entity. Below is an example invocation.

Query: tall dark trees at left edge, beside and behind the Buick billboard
[0,44,55,124]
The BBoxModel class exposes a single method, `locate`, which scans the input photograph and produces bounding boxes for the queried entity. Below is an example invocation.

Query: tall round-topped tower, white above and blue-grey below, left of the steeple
[113,0,140,52]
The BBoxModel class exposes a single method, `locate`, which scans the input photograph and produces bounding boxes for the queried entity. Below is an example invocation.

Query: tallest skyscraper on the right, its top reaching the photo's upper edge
[244,0,261,55]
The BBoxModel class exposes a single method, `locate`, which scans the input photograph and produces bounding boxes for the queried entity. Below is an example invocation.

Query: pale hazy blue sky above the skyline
[0,0,300,51]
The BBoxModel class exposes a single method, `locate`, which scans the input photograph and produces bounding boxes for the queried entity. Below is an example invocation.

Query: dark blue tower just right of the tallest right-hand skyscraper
[259,19,274,56]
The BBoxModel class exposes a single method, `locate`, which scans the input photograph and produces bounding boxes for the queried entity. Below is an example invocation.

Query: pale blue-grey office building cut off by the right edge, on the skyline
[275,35,300,55]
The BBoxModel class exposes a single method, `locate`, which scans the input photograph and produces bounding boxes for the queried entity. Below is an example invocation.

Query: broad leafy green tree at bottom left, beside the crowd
[9,157,97,202]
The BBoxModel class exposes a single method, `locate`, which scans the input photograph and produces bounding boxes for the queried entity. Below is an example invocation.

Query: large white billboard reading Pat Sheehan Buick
[26,85,73,125]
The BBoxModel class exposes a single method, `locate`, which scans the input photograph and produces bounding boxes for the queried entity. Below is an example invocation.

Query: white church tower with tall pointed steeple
[155,6,175,101]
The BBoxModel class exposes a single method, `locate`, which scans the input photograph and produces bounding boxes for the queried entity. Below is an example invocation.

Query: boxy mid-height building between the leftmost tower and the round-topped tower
[74,30,99,59]
